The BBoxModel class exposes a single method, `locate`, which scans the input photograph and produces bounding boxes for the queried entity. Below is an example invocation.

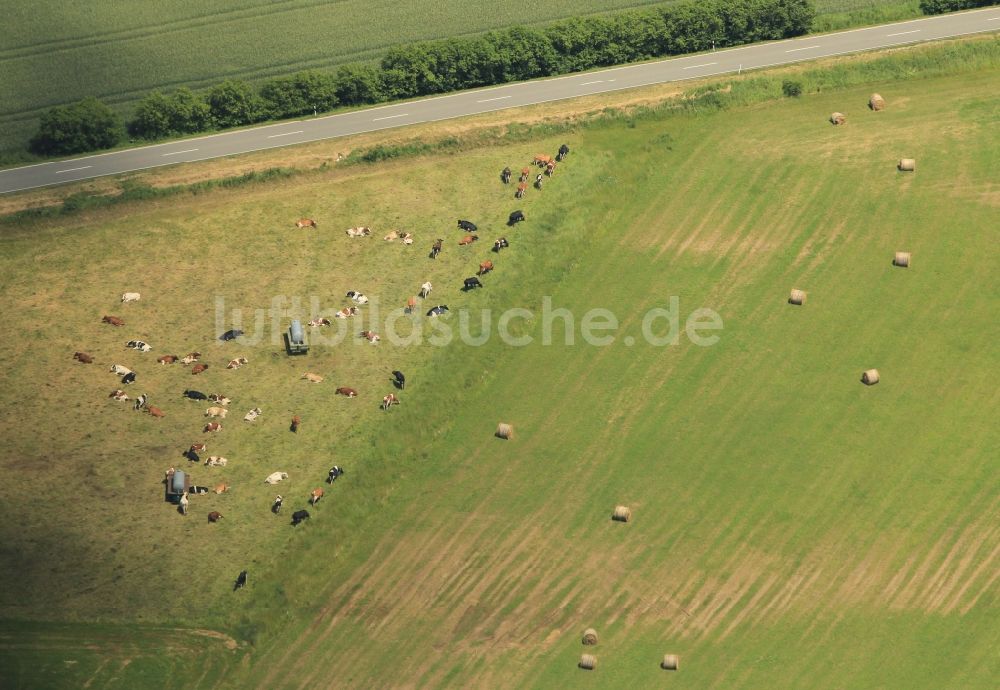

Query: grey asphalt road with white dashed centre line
[0,7,1000,194]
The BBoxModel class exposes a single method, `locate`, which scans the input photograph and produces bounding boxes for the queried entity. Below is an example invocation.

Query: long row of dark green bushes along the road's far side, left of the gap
[31,0,820,155]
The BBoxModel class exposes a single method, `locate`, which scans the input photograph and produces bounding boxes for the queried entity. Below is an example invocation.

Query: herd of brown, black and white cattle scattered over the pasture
[73,144,569,590]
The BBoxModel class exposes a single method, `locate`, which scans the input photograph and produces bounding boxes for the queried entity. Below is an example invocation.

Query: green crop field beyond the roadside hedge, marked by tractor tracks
[0,0,916,155]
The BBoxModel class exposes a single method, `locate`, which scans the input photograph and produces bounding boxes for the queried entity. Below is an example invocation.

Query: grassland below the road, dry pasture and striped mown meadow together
[0,41,1000,688]
